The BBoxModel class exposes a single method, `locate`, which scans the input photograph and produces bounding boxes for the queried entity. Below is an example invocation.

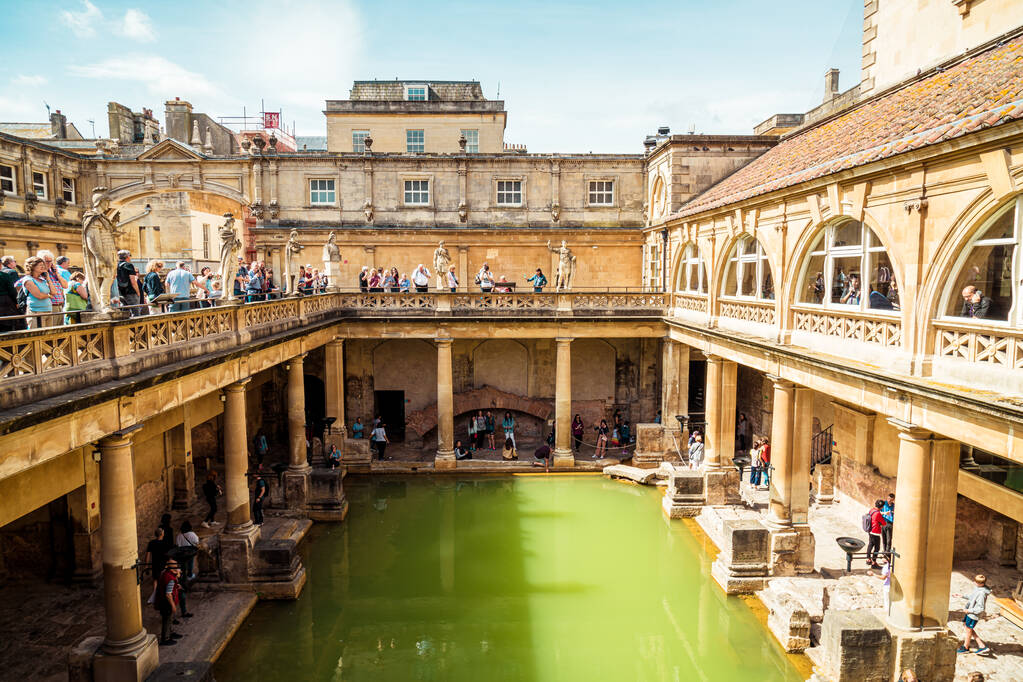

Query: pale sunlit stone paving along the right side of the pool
[699,482,1023,682]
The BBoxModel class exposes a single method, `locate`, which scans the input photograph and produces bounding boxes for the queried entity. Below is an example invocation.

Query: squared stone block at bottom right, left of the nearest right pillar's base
[820,610,892,682]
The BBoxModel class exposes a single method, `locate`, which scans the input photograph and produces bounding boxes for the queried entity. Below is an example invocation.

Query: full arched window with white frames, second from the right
[798,220,899,310]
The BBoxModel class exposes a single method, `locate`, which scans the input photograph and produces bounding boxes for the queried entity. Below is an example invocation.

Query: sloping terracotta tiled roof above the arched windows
[675,36,1023,217]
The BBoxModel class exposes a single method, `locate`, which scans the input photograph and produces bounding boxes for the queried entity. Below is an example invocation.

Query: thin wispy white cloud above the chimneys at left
[71,54,217,99]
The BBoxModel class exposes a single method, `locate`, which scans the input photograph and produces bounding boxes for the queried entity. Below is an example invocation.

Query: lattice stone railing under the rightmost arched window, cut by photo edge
[934,319,1023,369]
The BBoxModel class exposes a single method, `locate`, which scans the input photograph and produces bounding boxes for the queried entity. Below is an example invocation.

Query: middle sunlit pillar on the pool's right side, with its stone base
[766,376,814,576]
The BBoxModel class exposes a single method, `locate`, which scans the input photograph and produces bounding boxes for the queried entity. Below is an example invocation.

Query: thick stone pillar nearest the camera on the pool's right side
[888,419,960,680]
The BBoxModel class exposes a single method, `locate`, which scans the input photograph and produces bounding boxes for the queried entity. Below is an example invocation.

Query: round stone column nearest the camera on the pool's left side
[93,426,160,681]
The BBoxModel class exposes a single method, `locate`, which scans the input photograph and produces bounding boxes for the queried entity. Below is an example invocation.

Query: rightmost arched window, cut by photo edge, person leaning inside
[944,197,1023,323]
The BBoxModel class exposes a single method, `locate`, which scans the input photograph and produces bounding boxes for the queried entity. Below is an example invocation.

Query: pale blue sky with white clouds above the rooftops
[0,0,863,153]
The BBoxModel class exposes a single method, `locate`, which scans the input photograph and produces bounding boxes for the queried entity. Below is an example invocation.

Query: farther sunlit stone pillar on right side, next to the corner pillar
[701,356,740,505]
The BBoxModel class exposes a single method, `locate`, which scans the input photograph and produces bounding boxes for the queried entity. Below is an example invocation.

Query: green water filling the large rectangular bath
[214,475,802,682]
